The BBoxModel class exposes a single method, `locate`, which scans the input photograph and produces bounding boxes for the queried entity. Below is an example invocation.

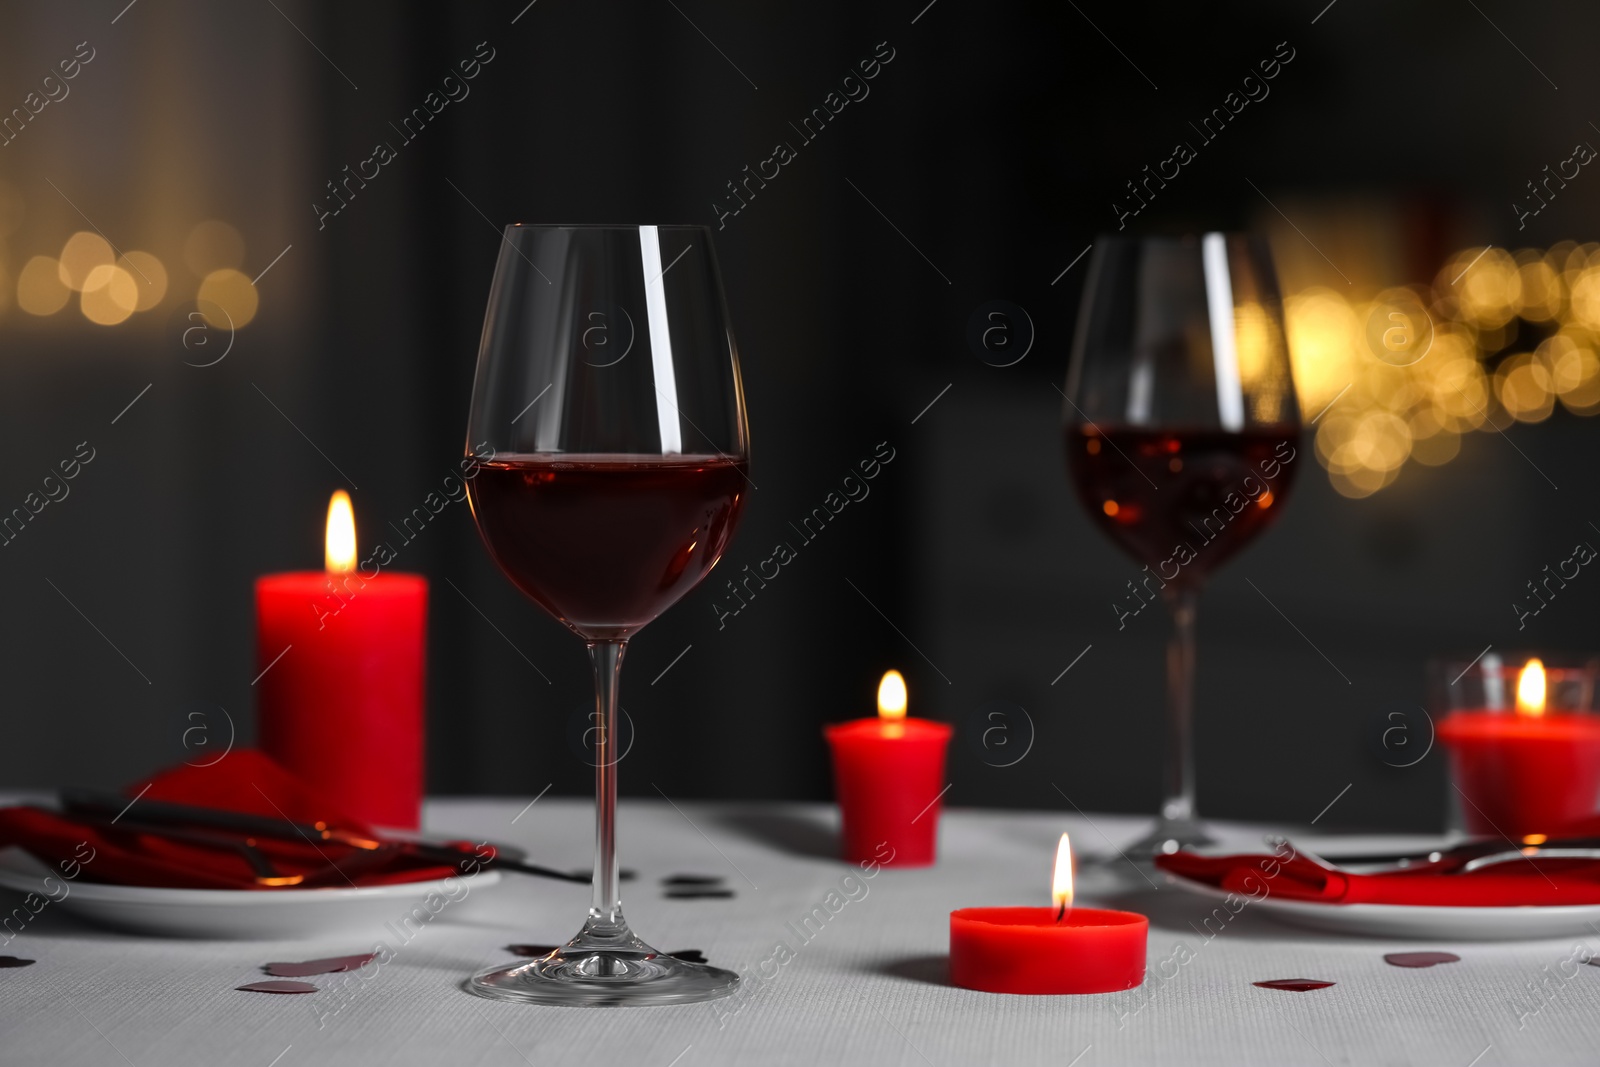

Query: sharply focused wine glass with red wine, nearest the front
[467,226,749,1005]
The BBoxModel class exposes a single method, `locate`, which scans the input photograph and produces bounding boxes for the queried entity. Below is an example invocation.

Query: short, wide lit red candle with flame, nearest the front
[950,833,1150,993]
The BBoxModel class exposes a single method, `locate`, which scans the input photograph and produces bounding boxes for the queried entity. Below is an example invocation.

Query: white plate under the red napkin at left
[0,848,499,941]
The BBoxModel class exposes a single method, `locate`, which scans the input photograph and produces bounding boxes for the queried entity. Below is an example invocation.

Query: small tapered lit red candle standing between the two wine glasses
[822,670,954,867]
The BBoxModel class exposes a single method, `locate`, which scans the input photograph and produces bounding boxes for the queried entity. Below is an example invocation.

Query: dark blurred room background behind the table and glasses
[0,0,1600,827]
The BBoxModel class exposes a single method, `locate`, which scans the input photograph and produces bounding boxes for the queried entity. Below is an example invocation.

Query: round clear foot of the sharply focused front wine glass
[466,945,739,1008]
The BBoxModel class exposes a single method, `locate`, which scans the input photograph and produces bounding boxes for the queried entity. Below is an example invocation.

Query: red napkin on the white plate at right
[1155,846,1600,907]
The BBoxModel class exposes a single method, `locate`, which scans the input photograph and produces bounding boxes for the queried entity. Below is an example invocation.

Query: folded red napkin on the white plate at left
[0,749,475,891]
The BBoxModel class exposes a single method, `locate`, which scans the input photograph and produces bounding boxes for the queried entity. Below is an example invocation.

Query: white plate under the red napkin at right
[1166,872,1600,941]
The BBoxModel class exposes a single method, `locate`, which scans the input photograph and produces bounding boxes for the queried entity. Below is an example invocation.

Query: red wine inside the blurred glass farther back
[1066,426,1299,587]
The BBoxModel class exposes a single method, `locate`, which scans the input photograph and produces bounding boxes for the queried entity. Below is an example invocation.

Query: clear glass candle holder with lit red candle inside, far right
[1429,649,1600,843]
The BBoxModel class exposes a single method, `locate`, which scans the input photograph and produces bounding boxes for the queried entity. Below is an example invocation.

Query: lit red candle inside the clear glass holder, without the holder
[1438,659,1600,838]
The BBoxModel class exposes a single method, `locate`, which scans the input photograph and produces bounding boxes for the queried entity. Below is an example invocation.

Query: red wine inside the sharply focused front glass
[467,454,747,640]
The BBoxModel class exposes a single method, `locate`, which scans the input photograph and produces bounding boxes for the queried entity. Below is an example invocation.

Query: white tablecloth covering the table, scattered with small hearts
[0,798,1600,1067]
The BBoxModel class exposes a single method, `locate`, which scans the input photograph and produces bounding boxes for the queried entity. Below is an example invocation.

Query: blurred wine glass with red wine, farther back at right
[1062,234,1301,853]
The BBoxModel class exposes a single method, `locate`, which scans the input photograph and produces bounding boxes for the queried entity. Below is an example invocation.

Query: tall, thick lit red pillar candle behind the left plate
[256,490,427,829]
